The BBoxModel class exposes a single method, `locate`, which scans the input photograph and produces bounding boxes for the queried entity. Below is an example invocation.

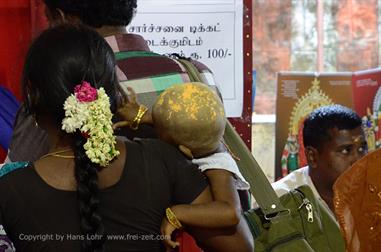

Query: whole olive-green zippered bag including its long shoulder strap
[167,55,345,252]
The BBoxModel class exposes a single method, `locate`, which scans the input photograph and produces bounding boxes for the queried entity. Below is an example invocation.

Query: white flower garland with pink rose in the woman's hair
[62,81,119,167]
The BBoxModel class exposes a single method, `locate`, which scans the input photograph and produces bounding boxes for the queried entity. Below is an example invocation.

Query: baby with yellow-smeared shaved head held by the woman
[115,82,250,250]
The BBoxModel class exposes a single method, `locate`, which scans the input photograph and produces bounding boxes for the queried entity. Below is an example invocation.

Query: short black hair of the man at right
[303,104,362,149]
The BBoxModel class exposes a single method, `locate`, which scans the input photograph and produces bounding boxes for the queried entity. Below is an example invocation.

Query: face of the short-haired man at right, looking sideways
[315,127,367,185]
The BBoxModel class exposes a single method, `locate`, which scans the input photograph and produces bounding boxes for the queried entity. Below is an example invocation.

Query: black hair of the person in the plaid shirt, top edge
[44,0,137,28]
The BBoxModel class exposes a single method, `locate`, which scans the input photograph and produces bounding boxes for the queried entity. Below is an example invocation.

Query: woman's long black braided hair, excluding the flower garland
[22,25,118,251]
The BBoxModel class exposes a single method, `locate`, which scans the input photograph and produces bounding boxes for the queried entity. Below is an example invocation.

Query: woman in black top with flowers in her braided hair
[0,26,224,252]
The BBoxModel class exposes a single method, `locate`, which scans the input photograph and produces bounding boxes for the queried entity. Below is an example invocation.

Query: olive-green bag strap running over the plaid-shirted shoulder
[173,54,288,216]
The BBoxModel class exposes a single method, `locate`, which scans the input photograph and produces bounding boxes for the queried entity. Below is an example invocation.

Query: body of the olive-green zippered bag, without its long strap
[244,185,345,252]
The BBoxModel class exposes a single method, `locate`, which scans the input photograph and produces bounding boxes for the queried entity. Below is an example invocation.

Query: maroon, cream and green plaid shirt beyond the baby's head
[106,34,220,108]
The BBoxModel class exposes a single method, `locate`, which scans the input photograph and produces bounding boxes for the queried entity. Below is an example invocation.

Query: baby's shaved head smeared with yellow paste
[152,82,226,157]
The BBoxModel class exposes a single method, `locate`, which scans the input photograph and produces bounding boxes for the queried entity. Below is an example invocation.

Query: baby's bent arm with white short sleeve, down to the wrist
[162,152,250,232]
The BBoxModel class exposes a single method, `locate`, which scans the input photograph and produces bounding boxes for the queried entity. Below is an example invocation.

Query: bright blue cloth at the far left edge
[0,86,20,150]
